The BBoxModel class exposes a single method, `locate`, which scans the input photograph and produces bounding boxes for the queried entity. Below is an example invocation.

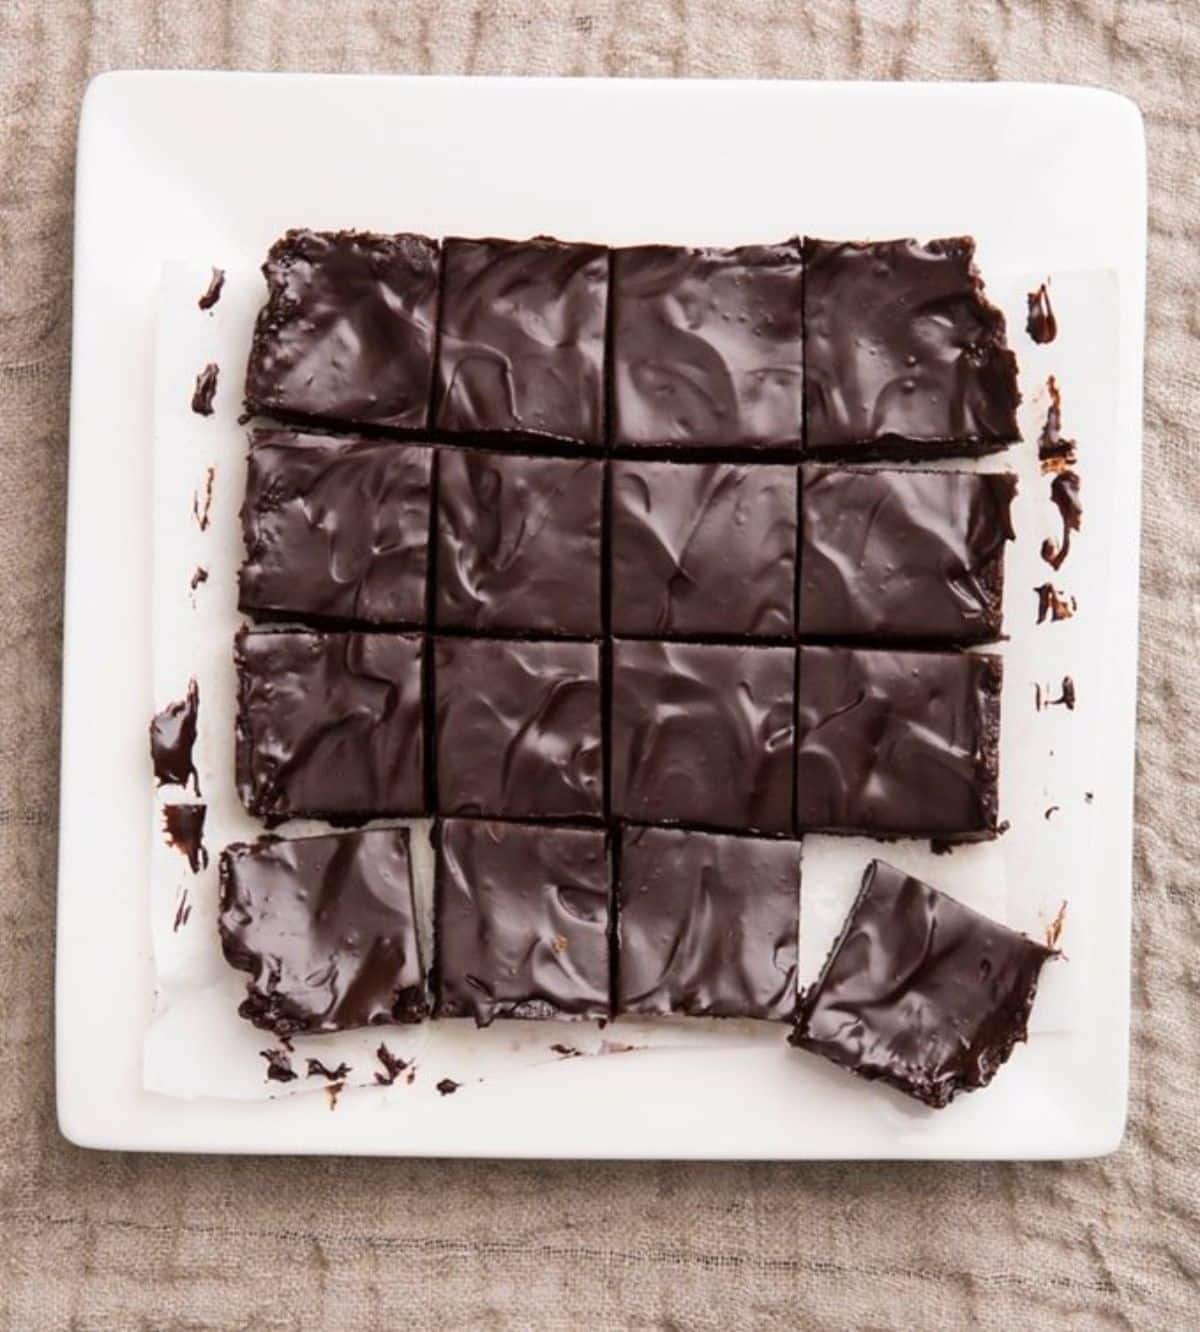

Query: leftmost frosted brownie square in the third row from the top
[234,630,425,826]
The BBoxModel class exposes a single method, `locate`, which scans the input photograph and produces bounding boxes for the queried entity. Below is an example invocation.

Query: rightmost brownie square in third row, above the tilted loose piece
[796,646,1002,840]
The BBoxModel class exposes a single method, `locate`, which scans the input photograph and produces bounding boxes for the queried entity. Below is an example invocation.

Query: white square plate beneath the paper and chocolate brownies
[57,73,1145,1159]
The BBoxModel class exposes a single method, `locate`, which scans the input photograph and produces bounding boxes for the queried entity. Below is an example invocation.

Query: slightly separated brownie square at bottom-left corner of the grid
[217,829,426,1036]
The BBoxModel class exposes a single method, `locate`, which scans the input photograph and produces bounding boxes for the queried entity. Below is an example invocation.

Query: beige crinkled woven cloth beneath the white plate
[0,0,1200,1332]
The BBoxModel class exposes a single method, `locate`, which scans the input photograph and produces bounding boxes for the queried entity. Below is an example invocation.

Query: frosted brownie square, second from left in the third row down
[434,638,603,818]
